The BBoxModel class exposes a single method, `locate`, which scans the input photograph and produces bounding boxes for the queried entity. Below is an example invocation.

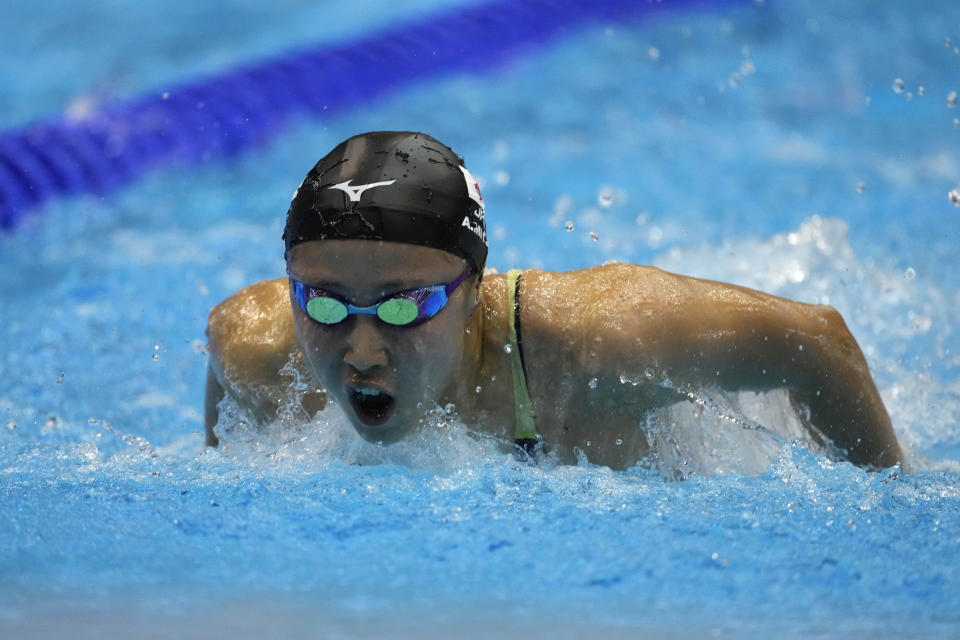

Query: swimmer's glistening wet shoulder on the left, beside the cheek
[207,278,297,383]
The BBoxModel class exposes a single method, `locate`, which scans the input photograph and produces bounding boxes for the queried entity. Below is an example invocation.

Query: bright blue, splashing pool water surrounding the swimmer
[0,0,960,638]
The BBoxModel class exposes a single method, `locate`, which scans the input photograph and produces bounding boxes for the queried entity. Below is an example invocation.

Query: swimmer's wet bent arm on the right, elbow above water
[596,271,903,466]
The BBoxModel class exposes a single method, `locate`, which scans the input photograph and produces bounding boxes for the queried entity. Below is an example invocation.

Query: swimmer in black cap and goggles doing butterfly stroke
[205,132,903,468]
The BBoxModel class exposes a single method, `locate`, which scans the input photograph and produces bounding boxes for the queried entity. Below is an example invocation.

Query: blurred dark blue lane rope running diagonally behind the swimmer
[0,0,736,228]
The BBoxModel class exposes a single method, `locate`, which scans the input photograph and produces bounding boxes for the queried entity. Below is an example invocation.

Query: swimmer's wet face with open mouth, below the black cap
[287,240,477,444]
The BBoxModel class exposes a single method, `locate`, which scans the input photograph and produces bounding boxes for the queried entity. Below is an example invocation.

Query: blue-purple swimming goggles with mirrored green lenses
[290,267,473,327]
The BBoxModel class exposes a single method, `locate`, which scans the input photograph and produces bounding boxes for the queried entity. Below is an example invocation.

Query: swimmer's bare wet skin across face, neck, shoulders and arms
[207,240,903,468]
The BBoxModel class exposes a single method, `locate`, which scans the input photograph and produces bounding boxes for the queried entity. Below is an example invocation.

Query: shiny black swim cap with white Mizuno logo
[283,131,487,275]
